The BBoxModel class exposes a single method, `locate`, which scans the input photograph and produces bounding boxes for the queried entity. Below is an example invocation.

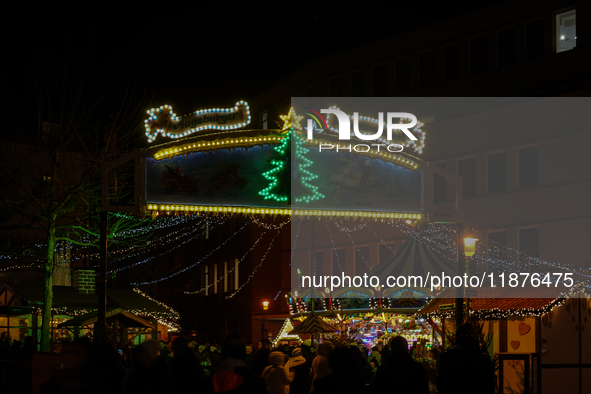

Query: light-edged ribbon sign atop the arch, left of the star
[144,101,250,142]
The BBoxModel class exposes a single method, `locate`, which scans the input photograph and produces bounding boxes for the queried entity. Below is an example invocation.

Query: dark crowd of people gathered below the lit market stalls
[1,325,494,394]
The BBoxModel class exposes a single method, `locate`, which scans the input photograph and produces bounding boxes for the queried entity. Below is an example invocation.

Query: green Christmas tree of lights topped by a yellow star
[259,108,325,204]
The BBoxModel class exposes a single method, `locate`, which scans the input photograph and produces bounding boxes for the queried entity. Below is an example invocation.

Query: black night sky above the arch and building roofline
[2,0,504,131]
